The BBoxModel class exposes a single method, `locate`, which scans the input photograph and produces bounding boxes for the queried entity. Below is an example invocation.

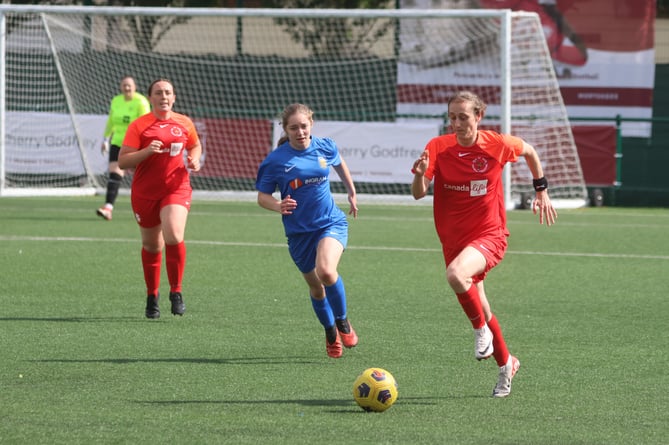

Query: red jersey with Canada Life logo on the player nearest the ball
[425,130,523,250]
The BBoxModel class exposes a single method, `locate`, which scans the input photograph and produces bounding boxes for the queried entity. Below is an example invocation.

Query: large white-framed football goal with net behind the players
[0,5,587,207]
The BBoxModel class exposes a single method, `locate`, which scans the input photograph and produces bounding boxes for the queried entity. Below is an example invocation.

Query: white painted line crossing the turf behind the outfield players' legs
[0,235,669,261]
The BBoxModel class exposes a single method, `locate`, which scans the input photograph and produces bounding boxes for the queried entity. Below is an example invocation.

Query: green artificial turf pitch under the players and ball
[0,197,669,445]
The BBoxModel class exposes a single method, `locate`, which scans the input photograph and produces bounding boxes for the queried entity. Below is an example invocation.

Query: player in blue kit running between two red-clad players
[256,104,358,358]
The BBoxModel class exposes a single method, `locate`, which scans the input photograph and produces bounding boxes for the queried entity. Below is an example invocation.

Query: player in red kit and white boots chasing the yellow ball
[411,91,557,397]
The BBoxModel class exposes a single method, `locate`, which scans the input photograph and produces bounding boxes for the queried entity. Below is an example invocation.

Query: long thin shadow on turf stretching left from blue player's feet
[30,356,322,365]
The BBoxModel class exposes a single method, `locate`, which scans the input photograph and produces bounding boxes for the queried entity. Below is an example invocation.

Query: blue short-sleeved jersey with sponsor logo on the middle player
[256,136,346,236]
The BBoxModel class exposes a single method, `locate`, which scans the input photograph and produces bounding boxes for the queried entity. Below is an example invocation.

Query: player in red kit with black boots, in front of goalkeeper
[118,79,202,318]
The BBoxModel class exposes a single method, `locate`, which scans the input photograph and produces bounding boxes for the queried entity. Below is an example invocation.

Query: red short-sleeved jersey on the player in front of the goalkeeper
[123,113,199,200]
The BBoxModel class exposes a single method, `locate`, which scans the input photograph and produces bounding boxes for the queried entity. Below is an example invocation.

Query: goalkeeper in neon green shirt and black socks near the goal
[97,76,151,221]
